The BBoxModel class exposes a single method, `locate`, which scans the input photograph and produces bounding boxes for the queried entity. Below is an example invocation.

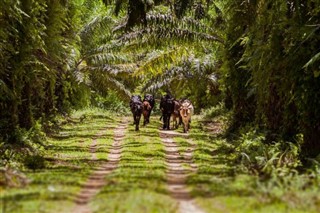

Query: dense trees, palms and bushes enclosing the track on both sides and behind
[0,0,320,211]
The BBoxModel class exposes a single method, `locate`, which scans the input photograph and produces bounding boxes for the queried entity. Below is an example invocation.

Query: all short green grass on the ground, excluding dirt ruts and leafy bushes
[0,109,320,213]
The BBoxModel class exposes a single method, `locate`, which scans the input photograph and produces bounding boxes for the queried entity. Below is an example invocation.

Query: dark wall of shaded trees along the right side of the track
[224,1,320,160]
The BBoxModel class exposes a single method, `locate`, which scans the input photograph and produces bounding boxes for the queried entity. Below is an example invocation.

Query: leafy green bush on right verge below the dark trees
[236,130,301,178]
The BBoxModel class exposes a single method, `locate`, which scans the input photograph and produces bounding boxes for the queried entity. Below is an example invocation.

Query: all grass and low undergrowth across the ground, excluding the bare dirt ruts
[1,105,320,213]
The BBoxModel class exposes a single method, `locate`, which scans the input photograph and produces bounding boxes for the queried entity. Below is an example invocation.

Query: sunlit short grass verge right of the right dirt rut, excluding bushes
[187,115,320,213]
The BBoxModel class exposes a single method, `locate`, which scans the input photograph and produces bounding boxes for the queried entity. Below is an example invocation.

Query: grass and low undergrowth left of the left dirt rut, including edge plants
[0,108,117,213]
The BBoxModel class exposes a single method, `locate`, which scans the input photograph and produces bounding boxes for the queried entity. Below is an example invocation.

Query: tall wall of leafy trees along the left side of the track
[0,0,95,142]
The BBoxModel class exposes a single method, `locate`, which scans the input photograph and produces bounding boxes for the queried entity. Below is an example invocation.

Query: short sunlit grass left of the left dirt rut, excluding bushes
[0,110,117,213]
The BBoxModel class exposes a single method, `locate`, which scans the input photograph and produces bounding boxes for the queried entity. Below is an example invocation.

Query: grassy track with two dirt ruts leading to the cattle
[0,111,318,213]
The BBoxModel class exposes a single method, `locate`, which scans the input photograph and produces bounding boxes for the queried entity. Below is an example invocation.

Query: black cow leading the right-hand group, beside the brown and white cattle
[160,94,174,130]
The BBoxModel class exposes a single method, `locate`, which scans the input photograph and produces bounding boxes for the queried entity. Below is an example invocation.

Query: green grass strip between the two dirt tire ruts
[90,117,177,213]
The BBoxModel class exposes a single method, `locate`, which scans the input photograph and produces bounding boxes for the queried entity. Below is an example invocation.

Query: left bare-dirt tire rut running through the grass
[73,120,128,213]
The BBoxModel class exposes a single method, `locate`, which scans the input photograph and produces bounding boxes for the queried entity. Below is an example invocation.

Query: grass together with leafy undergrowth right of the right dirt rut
[194,106,320,212]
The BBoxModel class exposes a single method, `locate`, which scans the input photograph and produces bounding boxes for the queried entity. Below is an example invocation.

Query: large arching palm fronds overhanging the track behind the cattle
[82,3,223,104]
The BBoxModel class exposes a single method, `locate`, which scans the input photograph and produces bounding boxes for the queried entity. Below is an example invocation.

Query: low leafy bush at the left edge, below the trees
[0,122,46,187]
